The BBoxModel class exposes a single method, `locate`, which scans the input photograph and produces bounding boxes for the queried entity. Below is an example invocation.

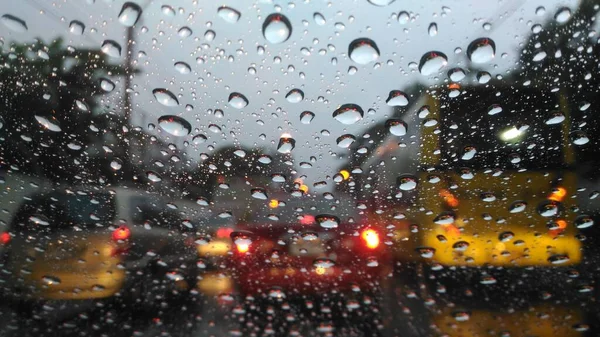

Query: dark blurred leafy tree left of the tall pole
[0,39,123,181]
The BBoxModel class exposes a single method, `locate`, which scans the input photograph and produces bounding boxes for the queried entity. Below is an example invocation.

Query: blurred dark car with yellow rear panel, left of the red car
[0,187,198,320]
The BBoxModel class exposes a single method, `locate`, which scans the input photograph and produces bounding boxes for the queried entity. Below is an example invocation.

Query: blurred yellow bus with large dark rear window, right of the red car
[412,86,586,267]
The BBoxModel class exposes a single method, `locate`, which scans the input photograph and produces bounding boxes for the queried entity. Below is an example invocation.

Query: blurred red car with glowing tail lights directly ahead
[230,200,391,335]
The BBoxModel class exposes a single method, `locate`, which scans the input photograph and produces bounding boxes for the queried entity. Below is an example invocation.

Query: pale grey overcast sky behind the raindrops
[0,0,577,186]
